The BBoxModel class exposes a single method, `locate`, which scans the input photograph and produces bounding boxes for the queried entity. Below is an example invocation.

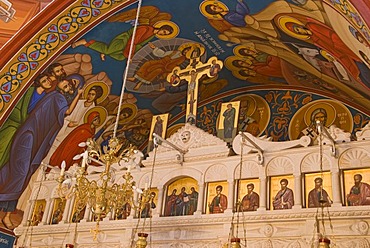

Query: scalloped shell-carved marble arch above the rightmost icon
[338,148,370,169]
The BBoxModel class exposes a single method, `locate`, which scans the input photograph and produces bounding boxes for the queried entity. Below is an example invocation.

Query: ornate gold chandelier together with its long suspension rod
[57,0,154,245]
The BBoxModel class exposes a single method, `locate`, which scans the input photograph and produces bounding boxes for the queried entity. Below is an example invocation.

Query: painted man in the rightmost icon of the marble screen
[347,174,370,206]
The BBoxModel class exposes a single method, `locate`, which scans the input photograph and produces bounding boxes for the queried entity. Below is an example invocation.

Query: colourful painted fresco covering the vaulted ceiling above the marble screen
[0,0,370,231]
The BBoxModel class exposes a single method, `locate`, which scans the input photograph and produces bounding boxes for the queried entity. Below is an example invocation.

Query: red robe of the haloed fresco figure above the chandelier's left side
[49,112,99,170]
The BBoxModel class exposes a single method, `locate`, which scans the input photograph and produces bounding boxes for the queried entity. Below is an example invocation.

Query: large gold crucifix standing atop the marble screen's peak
[167,56,223,125]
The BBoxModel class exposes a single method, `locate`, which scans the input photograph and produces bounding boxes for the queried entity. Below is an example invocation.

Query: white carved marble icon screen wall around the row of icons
[16,126,370,248]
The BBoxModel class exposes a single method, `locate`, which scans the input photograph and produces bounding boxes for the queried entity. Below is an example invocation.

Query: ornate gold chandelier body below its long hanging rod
[57,138,150,240]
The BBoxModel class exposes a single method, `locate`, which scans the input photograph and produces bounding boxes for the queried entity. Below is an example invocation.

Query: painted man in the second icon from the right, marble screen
[308,177,332,208]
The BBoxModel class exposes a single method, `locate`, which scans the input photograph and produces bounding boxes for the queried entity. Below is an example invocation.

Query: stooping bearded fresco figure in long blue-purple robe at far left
[0,80,82,229]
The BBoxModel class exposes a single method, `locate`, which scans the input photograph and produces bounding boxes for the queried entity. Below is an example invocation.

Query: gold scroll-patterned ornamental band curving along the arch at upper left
[0,0,132,121]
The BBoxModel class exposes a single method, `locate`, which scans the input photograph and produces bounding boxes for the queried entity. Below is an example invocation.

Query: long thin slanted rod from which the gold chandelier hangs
[113,0,142,138]
